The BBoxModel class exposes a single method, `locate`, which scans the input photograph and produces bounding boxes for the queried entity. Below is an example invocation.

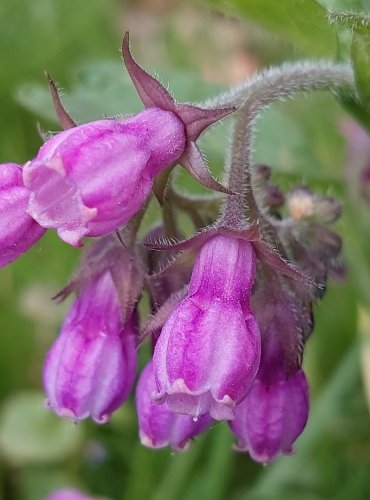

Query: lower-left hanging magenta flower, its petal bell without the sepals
[44,272,136,423]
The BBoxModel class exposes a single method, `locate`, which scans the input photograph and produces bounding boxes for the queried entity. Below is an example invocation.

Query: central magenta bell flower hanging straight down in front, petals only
[153,235,260,420]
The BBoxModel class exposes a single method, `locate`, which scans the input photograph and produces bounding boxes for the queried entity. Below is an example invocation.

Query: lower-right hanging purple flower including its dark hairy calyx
[229,270,313,463]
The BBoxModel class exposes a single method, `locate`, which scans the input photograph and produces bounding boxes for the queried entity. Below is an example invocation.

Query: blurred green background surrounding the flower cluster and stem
[0,0,370,500]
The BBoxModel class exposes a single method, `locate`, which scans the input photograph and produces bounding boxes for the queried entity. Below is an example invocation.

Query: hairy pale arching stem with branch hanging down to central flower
[207,61,354,223]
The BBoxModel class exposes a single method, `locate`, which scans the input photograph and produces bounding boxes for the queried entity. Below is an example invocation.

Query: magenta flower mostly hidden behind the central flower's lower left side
[136,362,212,451]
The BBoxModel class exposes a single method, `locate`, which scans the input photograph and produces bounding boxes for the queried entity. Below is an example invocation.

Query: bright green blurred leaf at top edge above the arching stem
[209,0,336,57]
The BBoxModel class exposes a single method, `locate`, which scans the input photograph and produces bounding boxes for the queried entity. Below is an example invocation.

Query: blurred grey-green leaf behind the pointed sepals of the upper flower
[16,60,221,122]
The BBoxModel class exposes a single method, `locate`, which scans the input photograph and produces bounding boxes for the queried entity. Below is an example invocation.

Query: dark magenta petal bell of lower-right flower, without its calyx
[229,342,309,463]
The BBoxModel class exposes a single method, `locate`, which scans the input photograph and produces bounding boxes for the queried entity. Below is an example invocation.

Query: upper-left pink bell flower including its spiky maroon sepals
[23,35,235,246]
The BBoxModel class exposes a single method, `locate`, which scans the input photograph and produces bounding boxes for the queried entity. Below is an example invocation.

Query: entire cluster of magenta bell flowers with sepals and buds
[0,37,341,464]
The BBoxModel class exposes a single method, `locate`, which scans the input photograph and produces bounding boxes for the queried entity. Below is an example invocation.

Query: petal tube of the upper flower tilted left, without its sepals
[23,108,186,246]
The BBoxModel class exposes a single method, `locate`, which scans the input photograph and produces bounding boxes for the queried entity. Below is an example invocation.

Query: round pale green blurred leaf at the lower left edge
[0,392,82,465]
